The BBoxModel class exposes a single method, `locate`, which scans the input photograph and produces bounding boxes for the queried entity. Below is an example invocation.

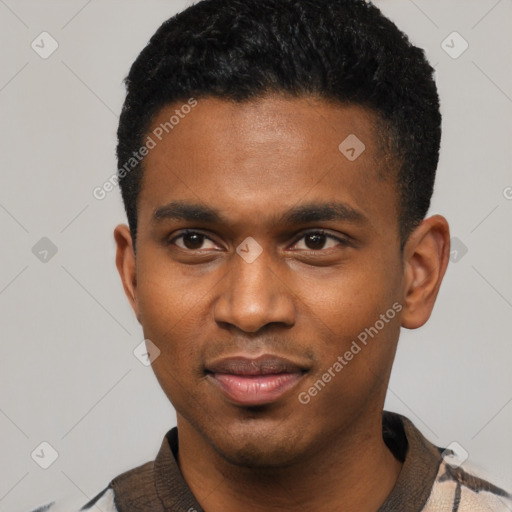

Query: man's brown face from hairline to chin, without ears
[127,96,403,466]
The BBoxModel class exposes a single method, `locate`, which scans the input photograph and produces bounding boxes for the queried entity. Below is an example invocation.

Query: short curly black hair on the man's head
[117,0,441,247]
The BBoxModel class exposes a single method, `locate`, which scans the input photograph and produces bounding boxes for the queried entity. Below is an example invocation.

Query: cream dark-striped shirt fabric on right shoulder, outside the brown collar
[423,460,512,512]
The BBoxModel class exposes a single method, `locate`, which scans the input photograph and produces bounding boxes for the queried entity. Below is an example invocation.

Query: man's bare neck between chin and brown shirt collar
[178,413,402,512]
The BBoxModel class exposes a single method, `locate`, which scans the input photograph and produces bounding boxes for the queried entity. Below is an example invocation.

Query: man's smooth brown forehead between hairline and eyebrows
[138,96,396,232]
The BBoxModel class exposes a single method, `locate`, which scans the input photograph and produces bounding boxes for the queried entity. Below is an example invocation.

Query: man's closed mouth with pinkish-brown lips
[206,354,308,406]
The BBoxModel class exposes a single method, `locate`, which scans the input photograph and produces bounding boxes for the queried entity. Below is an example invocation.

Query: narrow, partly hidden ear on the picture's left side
[114,224,140,321]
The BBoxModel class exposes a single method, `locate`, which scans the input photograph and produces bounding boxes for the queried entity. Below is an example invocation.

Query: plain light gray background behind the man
[0,0,512,512]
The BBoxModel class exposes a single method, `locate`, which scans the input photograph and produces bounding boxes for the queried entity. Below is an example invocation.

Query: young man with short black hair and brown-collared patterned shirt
[31,0,512,512]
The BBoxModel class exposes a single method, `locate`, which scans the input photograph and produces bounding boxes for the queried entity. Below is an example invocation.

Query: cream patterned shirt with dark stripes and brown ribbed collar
[29,411,512,512]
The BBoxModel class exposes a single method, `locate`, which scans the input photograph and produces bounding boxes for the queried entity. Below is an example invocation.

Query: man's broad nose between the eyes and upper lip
[214,247,295,333]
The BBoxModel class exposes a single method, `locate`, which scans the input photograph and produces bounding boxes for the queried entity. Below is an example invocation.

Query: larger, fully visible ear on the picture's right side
[402,215,450,329]
